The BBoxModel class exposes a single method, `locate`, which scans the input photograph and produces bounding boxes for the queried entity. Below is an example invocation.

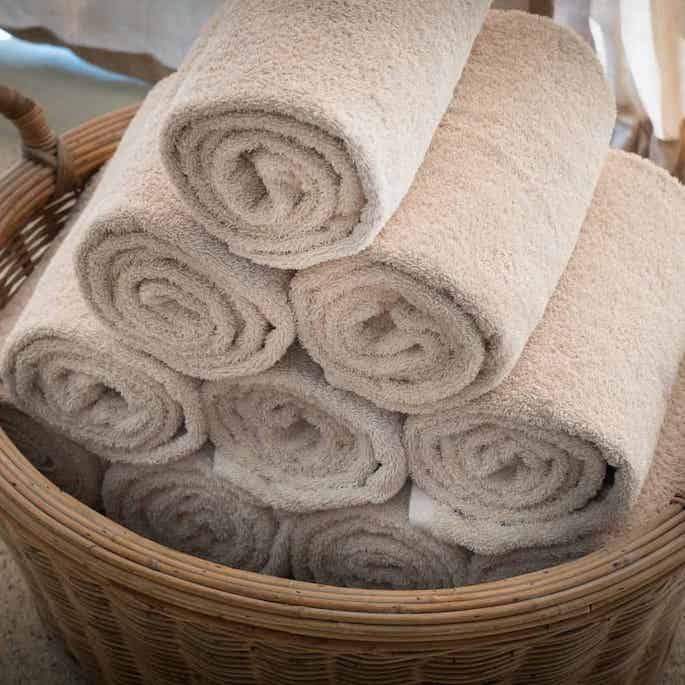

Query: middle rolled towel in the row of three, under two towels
[202,348,407,512]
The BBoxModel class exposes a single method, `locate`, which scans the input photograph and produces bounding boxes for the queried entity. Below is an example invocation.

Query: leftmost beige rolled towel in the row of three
[2,199,207,463]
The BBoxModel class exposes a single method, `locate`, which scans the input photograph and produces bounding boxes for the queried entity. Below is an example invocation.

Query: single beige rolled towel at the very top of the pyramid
[162,0,490,269]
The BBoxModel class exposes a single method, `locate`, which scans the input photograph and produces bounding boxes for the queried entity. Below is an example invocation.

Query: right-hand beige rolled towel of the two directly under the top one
[291,12,615,413]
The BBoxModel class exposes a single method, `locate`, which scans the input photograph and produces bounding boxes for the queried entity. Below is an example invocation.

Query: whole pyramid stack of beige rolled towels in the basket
[0,0,685,589]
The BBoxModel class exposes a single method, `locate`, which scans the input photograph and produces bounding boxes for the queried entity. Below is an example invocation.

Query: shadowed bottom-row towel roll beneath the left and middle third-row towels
[102,446,287,575]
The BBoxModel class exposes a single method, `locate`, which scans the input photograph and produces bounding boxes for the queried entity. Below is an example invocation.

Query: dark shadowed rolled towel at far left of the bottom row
[0,390,105,507]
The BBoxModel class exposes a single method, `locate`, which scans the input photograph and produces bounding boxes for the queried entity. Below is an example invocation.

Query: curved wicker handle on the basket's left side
[0,85,81,197]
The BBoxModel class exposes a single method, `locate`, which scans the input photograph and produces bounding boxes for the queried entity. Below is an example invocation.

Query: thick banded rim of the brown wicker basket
[0,106,685,648]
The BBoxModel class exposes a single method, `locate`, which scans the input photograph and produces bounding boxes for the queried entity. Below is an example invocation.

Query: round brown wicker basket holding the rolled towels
[0,90,685,685]
